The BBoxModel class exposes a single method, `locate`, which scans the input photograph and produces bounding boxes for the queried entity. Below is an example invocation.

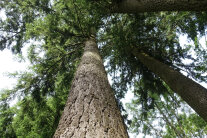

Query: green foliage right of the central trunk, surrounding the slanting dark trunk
[99,12,206,137]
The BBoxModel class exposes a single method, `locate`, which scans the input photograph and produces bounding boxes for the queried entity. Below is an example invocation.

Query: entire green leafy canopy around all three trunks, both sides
[0,0,207,137]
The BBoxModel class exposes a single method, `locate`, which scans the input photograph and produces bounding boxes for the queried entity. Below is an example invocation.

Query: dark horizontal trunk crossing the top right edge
[112,0,207,13]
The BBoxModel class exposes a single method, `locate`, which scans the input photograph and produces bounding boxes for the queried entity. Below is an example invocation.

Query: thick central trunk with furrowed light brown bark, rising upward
[54,39,128,138]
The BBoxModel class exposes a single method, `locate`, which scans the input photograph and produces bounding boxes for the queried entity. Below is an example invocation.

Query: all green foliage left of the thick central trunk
[0,0,105,138]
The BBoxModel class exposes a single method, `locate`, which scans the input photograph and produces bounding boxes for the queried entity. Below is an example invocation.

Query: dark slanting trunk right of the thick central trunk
[133,50,207,121]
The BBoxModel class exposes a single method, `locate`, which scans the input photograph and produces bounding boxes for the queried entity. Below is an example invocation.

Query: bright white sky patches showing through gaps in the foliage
[0,36,207,138]
